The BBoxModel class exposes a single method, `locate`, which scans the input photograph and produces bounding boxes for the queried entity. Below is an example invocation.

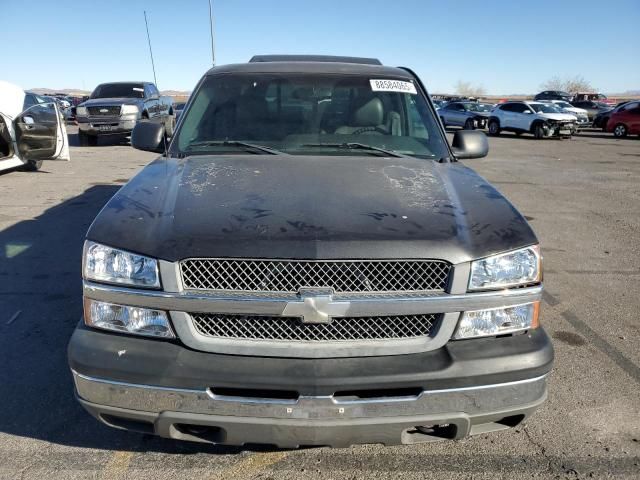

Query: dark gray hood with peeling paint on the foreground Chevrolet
[87,154,537,263]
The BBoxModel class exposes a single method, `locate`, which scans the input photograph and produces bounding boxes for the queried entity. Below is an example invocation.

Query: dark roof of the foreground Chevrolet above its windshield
[206,60,413,79]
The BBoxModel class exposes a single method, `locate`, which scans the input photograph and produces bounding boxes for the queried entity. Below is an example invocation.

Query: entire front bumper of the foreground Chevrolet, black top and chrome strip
[69,326,553,447]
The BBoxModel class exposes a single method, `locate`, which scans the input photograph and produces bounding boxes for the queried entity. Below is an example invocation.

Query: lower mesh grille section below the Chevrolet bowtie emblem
[191,313,439,342]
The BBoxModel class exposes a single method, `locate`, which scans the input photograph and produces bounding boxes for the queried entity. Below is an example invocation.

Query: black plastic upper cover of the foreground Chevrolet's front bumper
[68,323,554,395]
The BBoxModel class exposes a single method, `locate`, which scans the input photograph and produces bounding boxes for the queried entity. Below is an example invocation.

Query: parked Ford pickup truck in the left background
[76,82,176,146]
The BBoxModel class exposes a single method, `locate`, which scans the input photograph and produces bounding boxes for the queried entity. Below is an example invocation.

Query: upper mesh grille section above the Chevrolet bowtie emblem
[180,259,451,293]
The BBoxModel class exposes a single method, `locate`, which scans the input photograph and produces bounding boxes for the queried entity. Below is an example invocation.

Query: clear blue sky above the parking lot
[0,0,640,95]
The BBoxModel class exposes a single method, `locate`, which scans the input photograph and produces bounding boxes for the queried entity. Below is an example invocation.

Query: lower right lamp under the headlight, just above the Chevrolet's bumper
[453,302,540,340]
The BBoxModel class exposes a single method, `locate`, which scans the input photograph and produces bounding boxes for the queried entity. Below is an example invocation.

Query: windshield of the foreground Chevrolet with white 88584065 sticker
[172,73,449,159]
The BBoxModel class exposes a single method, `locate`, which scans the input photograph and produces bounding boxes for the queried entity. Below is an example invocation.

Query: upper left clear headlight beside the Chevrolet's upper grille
[83,241,160,288]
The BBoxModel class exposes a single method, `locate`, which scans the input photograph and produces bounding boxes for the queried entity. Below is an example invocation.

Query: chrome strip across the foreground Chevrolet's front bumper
[72,370,547,419]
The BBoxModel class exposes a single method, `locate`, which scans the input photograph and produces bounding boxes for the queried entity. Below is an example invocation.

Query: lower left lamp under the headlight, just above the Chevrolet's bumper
[84,298,175,338]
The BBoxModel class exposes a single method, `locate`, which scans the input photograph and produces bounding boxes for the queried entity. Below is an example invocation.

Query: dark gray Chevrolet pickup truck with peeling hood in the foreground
[68,56,553,447]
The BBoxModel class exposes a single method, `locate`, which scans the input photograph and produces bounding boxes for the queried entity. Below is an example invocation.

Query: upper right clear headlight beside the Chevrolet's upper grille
[469,245,542,290]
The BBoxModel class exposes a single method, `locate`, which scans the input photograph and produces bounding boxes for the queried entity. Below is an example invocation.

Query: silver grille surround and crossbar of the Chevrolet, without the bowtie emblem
[83,284,543,358]
